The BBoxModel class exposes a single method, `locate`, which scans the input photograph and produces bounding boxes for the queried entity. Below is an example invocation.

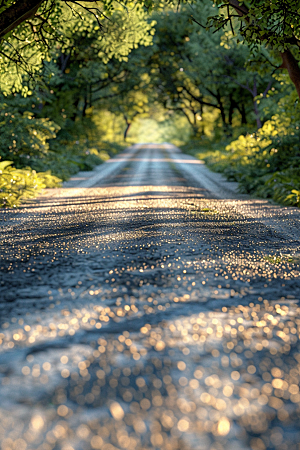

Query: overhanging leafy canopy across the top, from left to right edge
[0,0,300,96]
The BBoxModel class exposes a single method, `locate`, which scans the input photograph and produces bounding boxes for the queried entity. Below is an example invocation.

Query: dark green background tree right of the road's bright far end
[145,4,275,136]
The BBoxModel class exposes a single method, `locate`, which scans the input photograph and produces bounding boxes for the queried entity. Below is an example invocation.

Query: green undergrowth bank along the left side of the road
[0,94,125,207]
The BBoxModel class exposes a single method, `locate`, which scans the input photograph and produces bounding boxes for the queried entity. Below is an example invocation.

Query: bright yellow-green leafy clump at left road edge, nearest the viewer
[0,161,61,208]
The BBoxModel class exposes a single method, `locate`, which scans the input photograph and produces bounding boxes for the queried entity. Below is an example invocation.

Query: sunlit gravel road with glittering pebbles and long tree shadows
[0,144,300,450]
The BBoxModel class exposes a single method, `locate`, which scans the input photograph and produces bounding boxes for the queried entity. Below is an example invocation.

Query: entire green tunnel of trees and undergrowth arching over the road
[0,0,300,206]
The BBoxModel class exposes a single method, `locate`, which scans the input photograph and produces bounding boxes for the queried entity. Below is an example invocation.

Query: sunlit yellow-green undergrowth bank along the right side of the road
[182,116,300,207]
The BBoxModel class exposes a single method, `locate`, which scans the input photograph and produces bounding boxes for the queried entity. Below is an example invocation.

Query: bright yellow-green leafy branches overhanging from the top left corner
[0,0,154,94]
